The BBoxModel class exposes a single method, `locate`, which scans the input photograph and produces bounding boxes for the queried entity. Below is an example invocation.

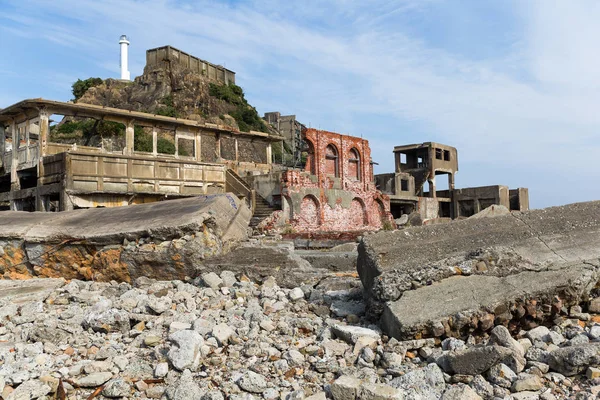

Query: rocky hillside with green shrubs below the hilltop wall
[74,63,272,132]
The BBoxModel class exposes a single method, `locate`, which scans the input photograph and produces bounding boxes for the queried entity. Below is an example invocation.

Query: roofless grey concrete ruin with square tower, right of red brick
[375,142,529,221]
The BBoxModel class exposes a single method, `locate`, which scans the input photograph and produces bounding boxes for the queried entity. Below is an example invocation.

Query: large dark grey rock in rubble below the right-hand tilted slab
[437,346,512,375]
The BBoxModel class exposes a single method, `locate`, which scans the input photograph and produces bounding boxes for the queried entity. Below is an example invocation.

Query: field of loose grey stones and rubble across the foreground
[0,271,600,400]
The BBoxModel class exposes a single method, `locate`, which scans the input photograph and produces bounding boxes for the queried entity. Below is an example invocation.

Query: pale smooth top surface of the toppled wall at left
[0,193,250,244]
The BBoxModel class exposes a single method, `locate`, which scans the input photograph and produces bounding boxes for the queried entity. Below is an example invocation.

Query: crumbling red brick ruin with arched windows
[281,129,393,233]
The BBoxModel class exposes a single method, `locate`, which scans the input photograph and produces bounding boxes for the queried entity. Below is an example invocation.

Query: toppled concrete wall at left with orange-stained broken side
[0,193,251,282]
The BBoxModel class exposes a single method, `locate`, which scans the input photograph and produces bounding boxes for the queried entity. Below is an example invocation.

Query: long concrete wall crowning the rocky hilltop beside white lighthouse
[146,46,235,85]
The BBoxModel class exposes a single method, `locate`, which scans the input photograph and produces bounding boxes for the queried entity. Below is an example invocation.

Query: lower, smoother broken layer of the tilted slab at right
[381,263,600,339]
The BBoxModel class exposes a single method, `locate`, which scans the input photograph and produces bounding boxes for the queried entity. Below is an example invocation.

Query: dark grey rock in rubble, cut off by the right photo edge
[548,342,600,376]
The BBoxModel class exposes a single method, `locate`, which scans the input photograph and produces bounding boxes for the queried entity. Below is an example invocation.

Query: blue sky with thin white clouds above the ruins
[0,0,600,208]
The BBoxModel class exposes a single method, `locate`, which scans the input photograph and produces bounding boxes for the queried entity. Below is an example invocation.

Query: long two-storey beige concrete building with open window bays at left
[0,99,281,211]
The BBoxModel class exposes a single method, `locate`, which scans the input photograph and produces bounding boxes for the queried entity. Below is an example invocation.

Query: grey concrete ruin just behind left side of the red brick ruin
[263,111,306,167]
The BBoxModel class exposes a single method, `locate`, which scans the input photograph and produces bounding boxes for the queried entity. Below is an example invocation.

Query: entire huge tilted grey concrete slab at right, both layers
[357,202,600,338]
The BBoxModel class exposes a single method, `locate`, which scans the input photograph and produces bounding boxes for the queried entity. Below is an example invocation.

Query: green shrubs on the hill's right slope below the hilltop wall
[208,83,268,132]
